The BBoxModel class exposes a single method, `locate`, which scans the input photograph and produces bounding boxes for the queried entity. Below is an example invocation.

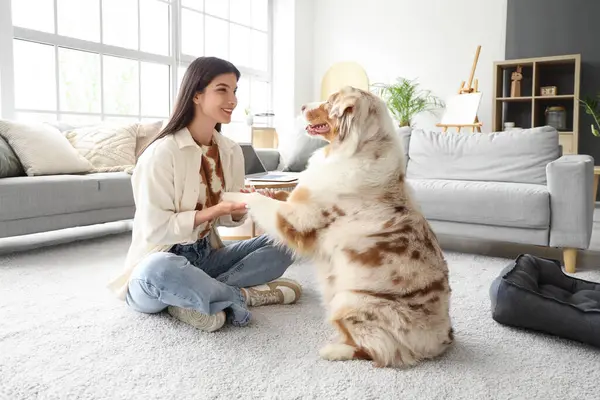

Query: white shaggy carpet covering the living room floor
[0,234,600,400]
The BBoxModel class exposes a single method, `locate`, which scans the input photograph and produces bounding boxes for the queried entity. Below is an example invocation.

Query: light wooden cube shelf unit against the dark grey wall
[492,54,581,154]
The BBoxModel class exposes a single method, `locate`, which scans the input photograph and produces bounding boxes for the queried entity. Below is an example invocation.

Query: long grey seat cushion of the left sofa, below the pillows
[0,172,134,221]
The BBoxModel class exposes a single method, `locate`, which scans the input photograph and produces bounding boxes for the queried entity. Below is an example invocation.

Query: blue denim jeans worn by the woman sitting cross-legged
[126,235,293,326]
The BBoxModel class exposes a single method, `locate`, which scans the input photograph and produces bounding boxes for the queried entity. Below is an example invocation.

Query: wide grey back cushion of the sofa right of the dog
[407,126,560,185]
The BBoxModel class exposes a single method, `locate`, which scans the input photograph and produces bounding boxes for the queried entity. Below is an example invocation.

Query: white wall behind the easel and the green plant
[308,0,507,132]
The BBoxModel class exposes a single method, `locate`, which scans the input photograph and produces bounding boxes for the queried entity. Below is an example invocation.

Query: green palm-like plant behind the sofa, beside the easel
[372,78,446,127]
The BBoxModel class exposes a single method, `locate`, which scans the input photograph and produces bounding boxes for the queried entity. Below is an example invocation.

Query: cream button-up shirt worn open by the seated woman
[109,128,246,300]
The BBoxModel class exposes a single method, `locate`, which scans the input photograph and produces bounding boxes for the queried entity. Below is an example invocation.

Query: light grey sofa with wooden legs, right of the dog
[270,127,594,272]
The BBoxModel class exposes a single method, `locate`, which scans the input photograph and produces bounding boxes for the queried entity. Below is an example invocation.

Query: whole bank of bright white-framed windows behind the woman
[0,0,271,140]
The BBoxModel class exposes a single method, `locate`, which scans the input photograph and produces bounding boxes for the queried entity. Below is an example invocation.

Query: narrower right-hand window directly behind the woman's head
[177,0,271,141]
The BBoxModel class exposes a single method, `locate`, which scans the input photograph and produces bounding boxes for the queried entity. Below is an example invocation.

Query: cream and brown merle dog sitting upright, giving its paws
[223,87,454,367]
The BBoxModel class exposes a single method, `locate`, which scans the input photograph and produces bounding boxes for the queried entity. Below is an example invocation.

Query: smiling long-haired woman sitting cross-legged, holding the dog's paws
[110,57,301,331]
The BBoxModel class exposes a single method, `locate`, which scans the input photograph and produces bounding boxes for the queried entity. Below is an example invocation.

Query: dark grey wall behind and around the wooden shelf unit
[505,0,600,165]
